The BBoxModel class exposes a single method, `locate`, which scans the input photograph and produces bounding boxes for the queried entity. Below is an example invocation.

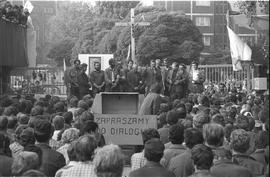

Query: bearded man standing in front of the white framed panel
[90,62,105,97]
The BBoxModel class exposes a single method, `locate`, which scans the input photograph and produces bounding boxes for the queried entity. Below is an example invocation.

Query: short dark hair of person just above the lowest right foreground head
[184,128,204,149]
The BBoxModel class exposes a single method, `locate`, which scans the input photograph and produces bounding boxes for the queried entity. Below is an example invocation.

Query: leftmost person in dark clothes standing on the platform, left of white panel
[64,59,81,98]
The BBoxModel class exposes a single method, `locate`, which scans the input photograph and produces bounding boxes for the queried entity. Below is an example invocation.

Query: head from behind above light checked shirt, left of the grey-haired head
[75,135,97,162]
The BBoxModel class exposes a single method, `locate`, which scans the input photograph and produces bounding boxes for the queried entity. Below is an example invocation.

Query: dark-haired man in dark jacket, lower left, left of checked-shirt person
[34,120,66,176]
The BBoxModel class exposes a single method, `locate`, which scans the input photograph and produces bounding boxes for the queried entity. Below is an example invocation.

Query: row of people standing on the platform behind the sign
[65,58,205,100]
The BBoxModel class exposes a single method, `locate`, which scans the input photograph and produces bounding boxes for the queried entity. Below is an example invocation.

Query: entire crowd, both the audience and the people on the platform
[0,57,269,177]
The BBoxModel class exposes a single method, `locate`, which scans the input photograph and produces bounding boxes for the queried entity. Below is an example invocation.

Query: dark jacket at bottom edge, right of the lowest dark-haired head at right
[211,159,252,177]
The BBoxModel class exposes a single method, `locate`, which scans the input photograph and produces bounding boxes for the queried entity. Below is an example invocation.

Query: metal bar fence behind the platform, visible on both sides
[7,64,253,95]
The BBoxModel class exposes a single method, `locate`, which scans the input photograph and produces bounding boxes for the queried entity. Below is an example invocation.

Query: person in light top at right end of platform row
[189,61,205,93]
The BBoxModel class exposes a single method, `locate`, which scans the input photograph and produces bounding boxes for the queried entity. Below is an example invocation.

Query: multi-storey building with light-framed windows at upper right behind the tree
[153,0,264,51]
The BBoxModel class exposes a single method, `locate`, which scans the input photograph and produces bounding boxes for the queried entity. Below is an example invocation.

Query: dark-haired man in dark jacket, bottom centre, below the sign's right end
[129,138,175,177]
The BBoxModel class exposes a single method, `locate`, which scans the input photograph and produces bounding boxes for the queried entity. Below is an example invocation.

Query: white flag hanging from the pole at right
[227,26,252,71]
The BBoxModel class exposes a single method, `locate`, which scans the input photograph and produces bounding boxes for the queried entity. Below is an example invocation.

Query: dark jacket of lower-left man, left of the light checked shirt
[37,143,66,176]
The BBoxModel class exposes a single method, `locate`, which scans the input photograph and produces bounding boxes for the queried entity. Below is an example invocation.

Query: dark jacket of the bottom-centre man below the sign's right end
[129,161,175,177]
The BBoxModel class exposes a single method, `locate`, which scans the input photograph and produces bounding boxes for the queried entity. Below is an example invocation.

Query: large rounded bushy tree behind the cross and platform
[99,7,203,64]
